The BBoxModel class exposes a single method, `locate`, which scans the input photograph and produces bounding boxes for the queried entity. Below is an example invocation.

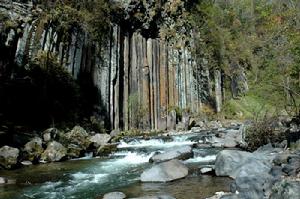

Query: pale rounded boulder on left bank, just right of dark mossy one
[41,141,67,162]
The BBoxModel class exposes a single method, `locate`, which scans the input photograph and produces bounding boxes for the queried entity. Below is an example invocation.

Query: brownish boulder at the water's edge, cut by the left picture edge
[0,146,20,169]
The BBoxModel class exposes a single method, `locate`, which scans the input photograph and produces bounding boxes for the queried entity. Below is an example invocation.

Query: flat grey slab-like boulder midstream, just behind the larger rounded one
[149,146,193,162]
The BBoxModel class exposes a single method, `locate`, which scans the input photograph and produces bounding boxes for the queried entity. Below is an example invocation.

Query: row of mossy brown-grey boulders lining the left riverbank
[0,126,116,169]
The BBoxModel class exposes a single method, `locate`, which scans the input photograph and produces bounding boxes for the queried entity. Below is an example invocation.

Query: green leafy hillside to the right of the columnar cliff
[190,0,300,118]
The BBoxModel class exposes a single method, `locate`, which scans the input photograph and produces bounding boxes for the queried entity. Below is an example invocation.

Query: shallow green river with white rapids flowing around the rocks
[0,134,230,199]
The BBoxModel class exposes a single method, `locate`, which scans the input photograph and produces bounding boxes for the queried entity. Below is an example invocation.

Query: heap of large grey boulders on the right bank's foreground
[215,144,300,199]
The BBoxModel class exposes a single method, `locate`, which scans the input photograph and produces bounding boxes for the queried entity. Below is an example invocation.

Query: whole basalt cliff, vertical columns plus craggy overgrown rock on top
[0,0,222,130]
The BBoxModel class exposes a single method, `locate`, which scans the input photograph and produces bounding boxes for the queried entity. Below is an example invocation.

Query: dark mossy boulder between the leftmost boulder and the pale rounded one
[24,137,44,162]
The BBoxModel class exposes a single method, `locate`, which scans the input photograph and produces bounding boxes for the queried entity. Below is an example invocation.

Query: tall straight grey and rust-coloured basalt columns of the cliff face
[1,0,216,130]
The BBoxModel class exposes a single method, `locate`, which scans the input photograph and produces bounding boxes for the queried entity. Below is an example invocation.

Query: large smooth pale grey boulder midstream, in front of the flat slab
[141,160,188,182]
